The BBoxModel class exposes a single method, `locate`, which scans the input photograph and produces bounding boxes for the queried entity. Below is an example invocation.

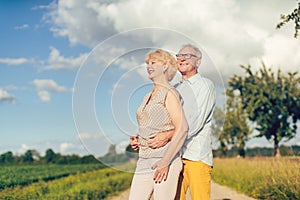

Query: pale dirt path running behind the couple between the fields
[108,182,255,200]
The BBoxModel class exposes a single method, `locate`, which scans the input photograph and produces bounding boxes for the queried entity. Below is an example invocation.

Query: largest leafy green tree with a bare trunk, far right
[229,63,300,156]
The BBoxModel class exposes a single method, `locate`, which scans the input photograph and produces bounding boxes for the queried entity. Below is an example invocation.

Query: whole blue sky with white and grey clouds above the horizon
[0,0,300,158]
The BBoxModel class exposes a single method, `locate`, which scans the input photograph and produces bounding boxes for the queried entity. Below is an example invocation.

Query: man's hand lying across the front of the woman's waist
[147,129,175,149]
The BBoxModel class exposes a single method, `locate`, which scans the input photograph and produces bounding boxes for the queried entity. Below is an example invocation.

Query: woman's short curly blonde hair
[145,49,177,81]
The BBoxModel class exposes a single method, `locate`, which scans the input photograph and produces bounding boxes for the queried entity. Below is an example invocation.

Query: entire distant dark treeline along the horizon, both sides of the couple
[0,145,300,166]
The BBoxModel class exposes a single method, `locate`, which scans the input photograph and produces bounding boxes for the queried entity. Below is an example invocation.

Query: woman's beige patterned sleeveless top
[136,86,175,158]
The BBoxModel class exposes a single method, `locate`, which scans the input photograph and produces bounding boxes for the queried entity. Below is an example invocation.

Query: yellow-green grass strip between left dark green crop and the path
[0,163,133,200]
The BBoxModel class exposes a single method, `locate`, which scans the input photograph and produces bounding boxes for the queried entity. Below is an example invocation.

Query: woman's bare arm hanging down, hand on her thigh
[152,89,188,182]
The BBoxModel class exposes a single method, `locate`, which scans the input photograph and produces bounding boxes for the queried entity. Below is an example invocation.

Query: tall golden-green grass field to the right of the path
[212,157,300,200]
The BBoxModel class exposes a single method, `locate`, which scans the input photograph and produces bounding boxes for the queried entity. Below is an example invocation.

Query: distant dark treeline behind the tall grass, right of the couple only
[213,145,300,157]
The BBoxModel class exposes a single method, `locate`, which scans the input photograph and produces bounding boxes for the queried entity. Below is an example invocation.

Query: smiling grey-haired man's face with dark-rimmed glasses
[176,47,201,75]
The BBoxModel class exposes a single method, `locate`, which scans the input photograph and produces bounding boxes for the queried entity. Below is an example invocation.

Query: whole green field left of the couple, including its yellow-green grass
[0,165,132,199]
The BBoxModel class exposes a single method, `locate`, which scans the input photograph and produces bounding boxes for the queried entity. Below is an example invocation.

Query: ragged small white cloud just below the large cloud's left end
[45,47,87,70]
